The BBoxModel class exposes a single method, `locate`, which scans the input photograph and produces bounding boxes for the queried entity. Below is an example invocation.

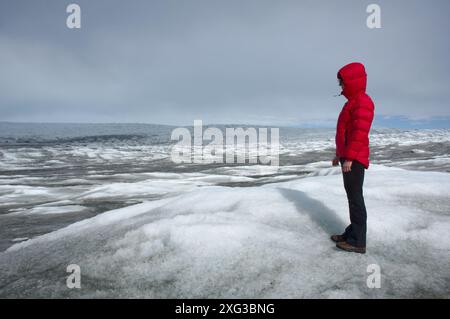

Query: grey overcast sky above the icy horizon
[0,0,450,125]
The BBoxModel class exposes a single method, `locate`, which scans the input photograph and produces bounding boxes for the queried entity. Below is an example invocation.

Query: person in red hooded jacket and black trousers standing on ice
[331,62,374,254]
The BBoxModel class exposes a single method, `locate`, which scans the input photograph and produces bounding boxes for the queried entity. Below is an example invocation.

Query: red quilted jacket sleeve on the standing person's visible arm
[344,97,373,161]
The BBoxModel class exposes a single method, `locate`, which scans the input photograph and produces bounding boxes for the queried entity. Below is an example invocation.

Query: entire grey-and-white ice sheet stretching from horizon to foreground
[0,124,450,298]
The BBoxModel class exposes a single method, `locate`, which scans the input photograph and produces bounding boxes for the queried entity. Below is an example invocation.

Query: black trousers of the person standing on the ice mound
[340,159,367,247]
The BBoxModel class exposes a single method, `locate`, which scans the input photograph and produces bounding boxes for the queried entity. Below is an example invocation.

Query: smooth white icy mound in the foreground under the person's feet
[0,165,450,298]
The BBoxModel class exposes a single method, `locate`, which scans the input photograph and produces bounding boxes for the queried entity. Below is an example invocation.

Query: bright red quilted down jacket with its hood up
[336,62,375,168]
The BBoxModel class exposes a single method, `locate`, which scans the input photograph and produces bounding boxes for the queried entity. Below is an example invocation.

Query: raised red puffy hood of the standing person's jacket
[337,62,367,99]
